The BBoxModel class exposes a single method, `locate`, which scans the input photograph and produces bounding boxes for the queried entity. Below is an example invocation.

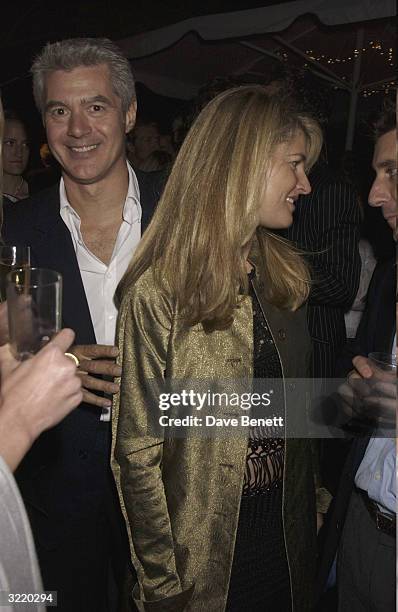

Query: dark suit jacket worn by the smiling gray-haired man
[3,167,163,552]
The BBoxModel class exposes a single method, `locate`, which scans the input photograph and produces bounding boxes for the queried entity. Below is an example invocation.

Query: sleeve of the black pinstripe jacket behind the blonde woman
[309,181,361,310]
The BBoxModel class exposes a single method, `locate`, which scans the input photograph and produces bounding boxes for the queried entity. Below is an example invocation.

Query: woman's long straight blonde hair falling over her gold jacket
[118,85,322,328]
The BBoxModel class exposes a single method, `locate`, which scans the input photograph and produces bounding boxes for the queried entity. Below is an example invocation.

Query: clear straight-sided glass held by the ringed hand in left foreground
[7,268,62,361]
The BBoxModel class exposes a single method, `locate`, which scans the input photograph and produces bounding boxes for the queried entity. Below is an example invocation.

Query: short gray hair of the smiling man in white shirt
[31,38,135,114]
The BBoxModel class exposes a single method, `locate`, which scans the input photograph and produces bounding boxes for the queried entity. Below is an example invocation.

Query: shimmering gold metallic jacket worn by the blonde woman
[112,269,316,612]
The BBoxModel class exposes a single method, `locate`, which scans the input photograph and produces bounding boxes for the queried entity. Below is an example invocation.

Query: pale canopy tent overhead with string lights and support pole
[118,0,396,149]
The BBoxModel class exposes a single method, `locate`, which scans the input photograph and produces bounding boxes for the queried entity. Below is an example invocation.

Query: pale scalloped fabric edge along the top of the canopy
[118,0,396,59]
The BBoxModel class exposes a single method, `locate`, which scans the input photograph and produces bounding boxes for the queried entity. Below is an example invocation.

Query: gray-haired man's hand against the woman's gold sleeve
[69,344,122,408]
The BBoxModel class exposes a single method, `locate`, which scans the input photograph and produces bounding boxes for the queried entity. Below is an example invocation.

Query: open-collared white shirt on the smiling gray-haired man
[59,164,141,421]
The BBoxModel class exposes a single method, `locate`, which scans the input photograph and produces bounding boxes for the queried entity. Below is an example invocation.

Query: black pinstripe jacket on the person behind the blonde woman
[286,165,361,378]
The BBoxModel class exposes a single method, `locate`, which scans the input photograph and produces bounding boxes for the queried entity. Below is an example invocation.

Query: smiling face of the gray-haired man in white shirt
[44,64,136,184]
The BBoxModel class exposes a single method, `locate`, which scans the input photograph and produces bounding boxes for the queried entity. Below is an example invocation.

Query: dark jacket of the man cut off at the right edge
[317,255,396,597]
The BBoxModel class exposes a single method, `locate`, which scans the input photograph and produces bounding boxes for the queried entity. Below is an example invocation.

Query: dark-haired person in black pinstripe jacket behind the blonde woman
[267,66,361,492]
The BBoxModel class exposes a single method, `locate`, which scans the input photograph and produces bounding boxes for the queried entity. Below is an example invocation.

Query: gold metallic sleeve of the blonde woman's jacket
[112,277,192,612]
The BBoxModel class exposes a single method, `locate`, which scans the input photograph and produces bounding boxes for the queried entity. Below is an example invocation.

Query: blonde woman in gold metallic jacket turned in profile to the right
[112,86,322,612]
